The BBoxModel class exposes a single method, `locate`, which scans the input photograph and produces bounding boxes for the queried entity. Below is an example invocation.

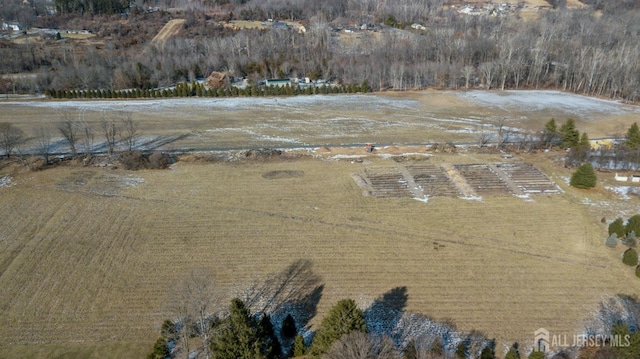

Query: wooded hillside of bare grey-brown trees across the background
[0,0,640,101]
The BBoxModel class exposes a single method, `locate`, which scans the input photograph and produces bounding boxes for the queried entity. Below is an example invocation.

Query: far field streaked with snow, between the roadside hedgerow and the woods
[0,91,640,151]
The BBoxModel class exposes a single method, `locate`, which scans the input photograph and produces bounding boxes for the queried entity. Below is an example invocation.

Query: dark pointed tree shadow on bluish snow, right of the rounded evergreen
[364,287,409,335]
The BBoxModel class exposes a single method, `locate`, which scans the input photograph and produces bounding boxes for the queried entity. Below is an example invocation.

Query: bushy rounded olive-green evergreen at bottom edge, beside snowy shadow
[309,299,367,358]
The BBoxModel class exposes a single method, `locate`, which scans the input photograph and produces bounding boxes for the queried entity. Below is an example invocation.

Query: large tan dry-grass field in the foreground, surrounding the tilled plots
[0,150,640,357]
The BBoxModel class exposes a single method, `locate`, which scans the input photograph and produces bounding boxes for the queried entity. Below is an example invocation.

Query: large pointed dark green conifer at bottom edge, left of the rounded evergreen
[211,299,271,359]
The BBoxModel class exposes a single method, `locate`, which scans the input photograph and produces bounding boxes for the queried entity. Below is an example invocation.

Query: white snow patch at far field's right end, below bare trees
[452,90,640,119]
